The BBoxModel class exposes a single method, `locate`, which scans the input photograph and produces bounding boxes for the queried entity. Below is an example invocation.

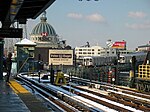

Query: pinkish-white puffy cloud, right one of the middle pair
[86,13,105,22]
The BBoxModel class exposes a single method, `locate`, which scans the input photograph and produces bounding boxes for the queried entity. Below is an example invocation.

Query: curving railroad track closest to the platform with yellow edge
[16,75,86,112]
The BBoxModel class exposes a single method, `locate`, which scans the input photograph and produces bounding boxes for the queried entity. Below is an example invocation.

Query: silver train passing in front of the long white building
[82,52,146,66]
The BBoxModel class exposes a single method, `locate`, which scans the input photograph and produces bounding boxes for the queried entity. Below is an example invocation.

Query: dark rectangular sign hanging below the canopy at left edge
[0,28,23,38]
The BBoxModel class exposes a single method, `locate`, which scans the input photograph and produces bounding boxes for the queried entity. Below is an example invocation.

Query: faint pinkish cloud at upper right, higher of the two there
[128,11,147,18]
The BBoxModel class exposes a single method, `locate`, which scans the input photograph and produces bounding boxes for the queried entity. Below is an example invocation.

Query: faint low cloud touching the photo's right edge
[126,22,150,30]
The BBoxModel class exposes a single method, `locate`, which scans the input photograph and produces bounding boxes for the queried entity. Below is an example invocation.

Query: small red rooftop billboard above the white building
[112,41,126,49]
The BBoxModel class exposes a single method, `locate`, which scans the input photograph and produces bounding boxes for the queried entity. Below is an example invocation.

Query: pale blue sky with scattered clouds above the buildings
[27,0,150,49]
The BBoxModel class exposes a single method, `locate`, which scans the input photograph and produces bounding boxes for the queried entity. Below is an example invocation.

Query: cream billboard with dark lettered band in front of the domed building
[49,49,73,65]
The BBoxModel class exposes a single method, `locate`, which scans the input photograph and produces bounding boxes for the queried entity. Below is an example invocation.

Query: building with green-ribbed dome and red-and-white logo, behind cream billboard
[30,12,73,65]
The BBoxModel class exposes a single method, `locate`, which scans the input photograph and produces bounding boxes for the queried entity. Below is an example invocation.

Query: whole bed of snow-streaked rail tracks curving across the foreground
[14,75,150,112]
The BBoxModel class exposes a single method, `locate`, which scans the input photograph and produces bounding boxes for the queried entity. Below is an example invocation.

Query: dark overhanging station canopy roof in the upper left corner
[0,0,55,28]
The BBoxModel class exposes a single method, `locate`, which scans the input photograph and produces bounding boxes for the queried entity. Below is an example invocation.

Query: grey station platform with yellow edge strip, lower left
[0,75,52,112]
